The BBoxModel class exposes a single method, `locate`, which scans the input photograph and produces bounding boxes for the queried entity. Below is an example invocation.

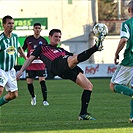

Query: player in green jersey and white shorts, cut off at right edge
[110,0,133,123]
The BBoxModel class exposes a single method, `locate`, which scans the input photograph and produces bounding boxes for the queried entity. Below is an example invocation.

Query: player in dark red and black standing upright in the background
[22,23,49,106]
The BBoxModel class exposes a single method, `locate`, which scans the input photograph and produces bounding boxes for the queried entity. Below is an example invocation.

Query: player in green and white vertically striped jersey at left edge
[0,15,26,106]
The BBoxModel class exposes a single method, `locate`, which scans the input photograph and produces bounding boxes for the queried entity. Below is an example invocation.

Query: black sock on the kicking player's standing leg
[80,90,91,115]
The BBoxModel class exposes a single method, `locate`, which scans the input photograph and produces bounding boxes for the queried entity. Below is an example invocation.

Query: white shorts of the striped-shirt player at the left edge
[0,68,18,92]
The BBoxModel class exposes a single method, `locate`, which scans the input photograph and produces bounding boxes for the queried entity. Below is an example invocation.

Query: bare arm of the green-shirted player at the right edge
[114,38,128,65]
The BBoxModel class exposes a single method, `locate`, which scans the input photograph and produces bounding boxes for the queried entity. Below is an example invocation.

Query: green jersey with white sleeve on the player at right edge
[120,18,133,66]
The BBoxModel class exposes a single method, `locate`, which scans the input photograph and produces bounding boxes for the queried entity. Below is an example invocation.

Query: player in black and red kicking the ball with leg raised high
[17,29,102,120]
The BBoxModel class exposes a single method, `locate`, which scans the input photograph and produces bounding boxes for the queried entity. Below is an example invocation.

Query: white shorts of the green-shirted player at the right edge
[111,65,133,85]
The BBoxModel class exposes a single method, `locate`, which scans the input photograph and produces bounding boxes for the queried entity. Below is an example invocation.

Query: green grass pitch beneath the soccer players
[0,79,133,133]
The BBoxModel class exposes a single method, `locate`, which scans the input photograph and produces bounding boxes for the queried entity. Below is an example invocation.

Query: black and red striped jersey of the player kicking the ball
[32,44,73,69]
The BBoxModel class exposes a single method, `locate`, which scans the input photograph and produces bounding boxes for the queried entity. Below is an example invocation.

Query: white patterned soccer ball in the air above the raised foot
[93,23,108,37]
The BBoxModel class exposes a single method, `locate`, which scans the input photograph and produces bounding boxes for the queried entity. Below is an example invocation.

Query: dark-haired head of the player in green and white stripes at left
[2,15,14,33]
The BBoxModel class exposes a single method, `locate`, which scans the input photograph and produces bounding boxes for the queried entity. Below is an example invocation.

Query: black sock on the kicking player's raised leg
[77,45,97,62]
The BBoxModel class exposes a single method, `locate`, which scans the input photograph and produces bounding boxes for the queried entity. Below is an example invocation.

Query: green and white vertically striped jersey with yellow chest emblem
[0,33,20,71]
